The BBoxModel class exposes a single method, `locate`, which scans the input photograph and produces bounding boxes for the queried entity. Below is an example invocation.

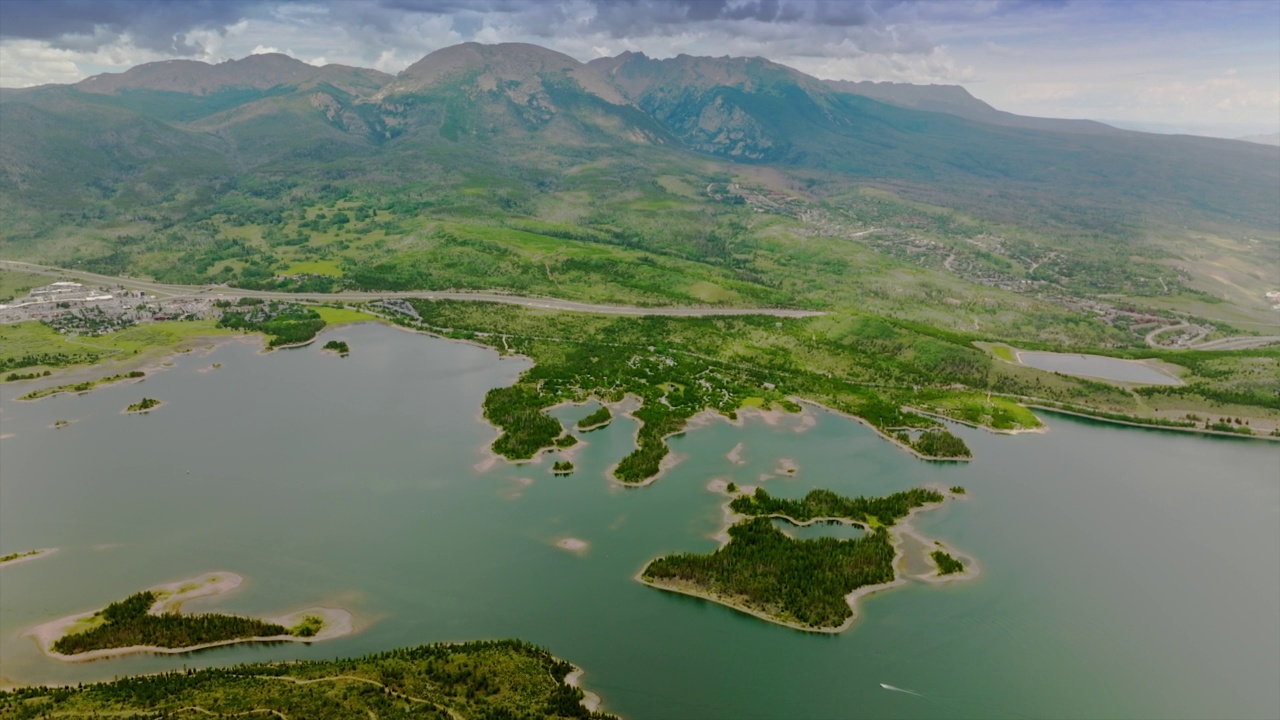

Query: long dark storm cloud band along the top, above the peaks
[0,0,967,55]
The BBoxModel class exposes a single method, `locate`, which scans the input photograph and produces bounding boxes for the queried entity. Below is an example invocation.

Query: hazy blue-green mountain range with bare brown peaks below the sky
[0,42,1280,298]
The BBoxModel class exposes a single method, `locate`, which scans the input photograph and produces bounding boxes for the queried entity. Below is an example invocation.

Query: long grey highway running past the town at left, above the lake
[0,260,824,318]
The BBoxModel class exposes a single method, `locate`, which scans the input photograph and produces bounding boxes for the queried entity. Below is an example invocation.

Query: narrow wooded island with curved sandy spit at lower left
[28,573,352,661]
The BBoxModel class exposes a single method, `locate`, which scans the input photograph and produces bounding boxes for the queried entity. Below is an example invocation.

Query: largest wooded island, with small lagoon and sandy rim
[636,483,975,633]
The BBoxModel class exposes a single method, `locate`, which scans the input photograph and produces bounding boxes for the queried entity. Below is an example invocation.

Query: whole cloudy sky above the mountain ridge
[0,0,1280,137]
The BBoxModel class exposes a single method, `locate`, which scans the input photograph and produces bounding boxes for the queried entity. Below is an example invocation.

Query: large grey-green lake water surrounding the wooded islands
[0,324,1280,720]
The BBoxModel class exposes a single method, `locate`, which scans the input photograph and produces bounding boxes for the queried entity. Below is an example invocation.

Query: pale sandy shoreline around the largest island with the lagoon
[634,478,979,634]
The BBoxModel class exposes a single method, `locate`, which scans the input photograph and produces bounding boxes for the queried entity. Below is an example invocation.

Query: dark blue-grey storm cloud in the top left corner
[0,0,270,53]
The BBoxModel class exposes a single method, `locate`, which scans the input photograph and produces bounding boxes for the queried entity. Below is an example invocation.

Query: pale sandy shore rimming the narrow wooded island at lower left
[23,573,355,662]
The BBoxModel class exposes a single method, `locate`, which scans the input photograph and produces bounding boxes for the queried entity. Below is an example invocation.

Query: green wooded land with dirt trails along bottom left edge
[0,641,613,720]
